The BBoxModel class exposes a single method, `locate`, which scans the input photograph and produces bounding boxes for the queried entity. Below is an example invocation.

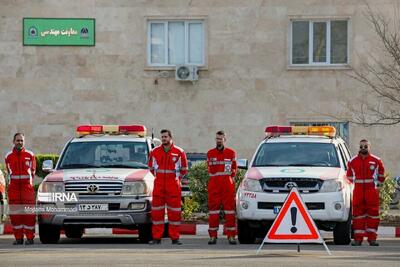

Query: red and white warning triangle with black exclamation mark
[264,187,323,243]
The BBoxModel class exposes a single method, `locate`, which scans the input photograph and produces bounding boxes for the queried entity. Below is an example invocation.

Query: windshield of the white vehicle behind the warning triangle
[253,142,340,167]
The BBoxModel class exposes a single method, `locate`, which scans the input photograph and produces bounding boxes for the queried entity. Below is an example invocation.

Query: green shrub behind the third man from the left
[189,162,246,213]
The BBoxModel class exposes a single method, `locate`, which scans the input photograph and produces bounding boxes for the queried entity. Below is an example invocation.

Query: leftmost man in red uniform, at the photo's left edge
[5,133,36,245]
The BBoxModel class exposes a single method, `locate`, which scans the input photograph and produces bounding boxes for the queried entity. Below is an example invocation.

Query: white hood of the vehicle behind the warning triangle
[246,167,342,180]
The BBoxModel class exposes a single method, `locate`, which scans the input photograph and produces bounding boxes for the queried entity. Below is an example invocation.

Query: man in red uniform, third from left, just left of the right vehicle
[207,131,237,245]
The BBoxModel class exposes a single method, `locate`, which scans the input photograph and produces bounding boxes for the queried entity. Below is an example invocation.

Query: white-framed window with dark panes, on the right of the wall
[291,19,348,65]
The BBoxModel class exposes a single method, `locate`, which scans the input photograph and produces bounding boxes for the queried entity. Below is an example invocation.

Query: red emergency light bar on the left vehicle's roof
[76,124,146,137]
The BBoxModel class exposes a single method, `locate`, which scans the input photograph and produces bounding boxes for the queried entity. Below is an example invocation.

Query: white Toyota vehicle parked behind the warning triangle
[236,126,352,244]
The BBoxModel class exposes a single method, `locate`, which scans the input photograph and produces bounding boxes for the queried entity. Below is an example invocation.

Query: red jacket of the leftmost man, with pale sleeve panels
[6,148,36,184]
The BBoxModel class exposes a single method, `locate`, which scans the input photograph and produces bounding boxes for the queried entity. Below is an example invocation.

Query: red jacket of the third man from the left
[207,147,237,177]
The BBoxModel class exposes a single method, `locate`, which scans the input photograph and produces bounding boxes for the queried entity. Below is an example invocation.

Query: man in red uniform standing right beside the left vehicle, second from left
[148,129,187,245]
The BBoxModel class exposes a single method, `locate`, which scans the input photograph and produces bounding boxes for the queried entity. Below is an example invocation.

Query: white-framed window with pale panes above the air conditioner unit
[147,20,204,66]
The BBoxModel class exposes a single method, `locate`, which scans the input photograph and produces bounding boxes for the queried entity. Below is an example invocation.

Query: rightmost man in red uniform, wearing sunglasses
[347,139,385,246]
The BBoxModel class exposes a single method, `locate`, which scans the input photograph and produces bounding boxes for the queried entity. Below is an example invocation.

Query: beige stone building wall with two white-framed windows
[0,0,400,175]
